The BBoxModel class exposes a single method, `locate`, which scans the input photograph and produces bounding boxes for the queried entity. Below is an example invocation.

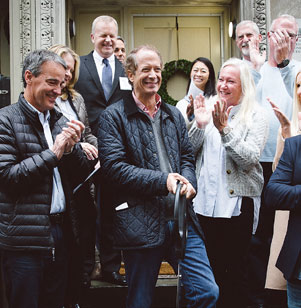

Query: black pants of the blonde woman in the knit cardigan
[198,198,254,308]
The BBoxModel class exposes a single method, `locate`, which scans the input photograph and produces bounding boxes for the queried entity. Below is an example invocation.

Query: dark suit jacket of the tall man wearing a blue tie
[75,51,125,136]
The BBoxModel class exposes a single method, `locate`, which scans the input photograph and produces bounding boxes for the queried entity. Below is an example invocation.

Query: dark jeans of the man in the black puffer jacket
[2,225,67,308]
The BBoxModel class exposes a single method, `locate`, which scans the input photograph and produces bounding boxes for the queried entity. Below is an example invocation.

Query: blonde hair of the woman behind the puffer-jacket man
[49,44,80,100]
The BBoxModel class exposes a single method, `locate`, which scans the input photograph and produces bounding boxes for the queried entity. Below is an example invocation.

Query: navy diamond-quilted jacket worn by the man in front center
[98,93,201,249]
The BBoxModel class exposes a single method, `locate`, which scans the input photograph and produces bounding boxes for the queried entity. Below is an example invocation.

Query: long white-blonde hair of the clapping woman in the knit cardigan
[221,58,258,127]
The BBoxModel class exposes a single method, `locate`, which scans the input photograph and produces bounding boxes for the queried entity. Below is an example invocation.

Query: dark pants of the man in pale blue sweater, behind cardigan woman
[246,162,275,305]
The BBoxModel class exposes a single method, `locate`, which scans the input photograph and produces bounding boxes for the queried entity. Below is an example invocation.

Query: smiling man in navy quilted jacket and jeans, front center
[98,46,218,308]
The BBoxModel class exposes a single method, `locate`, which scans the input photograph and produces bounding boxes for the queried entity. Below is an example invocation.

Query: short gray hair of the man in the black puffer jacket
[22,49,67,88]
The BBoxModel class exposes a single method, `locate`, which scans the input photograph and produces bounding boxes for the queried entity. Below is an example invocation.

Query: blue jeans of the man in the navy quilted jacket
[124,222,219,308]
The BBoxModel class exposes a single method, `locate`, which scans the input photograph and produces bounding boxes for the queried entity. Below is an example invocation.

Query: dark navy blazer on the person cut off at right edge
[265,136,301,280]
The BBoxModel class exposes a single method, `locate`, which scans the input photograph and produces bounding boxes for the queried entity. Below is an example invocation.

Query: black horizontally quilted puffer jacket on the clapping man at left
[0,95,90,250]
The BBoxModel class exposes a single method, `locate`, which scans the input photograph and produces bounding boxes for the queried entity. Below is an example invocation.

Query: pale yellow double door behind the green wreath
[133,16,221,100]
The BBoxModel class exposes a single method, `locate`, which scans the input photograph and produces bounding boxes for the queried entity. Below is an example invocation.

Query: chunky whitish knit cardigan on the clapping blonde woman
[188,107,268,197]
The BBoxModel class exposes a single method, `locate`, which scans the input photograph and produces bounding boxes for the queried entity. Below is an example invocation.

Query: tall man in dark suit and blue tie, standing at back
[75,16,127,285]
